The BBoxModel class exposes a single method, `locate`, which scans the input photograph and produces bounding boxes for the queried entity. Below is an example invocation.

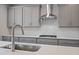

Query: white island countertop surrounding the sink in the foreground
[0,41,79,55]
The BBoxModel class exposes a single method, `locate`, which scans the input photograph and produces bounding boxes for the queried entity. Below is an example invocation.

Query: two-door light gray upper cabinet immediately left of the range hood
[23,6,40,27]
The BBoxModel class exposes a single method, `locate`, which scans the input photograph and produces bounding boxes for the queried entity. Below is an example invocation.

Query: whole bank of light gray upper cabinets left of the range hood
[8,5,40,27]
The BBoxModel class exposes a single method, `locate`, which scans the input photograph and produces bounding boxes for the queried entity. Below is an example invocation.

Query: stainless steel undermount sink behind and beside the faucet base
[2,44,40,52]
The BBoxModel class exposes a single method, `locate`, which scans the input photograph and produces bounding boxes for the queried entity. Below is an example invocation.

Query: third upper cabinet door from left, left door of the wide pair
[23,7,32,27]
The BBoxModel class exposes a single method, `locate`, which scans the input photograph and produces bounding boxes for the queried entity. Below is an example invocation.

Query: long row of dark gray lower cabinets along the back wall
[1,36,79,47]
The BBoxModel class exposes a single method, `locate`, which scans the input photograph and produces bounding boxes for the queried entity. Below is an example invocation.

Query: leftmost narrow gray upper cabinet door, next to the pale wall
[7,8,15,27]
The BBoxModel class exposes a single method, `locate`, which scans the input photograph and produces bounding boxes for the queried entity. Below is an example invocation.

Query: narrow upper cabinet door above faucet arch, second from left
[14,7,22,25]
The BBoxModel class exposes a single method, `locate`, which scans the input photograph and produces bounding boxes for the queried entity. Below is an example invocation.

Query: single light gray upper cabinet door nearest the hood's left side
[32,6,40,26]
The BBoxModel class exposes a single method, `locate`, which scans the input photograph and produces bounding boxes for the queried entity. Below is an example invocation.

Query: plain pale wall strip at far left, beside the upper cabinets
[0,5,9,36]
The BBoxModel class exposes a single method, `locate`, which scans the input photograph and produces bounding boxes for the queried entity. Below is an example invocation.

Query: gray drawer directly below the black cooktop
[37,39,57,45]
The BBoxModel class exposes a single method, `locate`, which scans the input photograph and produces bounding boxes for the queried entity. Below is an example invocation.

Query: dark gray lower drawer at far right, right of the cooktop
[59,39,79,47]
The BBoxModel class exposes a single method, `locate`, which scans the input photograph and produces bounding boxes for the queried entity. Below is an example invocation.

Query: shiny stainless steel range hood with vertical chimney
[41,4,56,19]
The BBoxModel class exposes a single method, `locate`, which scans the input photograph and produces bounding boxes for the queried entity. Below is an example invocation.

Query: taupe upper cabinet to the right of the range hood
[59,4,79,27]
